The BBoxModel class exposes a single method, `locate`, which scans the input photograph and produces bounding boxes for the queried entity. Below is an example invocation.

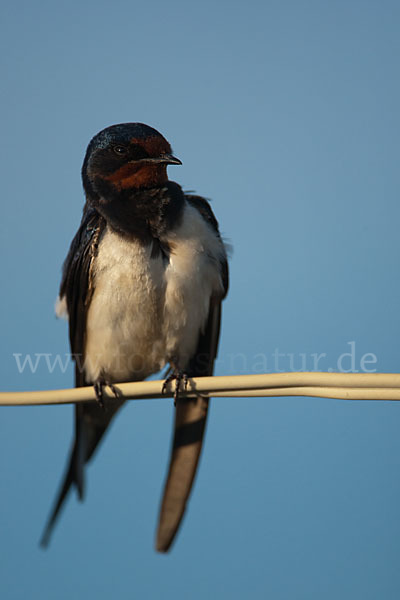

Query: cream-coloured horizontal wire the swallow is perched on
[0,372,400,406]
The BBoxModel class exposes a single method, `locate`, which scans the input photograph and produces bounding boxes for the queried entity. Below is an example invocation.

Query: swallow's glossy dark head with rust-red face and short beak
[82,123,182,196]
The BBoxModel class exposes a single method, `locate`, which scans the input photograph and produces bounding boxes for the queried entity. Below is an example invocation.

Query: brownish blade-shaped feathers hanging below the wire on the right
[156,396,209,552]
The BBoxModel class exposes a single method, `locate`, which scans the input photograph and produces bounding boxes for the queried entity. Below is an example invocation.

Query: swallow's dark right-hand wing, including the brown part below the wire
[156,195,229,552]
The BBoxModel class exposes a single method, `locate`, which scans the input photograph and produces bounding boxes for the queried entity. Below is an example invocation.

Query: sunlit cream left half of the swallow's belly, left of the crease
[85,229,165,381]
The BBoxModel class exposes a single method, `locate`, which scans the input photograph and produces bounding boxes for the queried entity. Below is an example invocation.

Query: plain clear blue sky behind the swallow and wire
[0,0,400,600]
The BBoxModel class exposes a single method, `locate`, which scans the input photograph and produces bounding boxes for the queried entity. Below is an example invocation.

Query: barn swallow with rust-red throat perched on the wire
[41,123,229,552]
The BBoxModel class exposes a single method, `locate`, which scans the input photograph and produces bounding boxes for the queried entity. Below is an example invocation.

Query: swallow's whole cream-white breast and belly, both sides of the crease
[81,204,225,382]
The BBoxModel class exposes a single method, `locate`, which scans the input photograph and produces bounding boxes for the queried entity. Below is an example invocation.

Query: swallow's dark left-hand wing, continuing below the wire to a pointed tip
[41,205,121,546]
